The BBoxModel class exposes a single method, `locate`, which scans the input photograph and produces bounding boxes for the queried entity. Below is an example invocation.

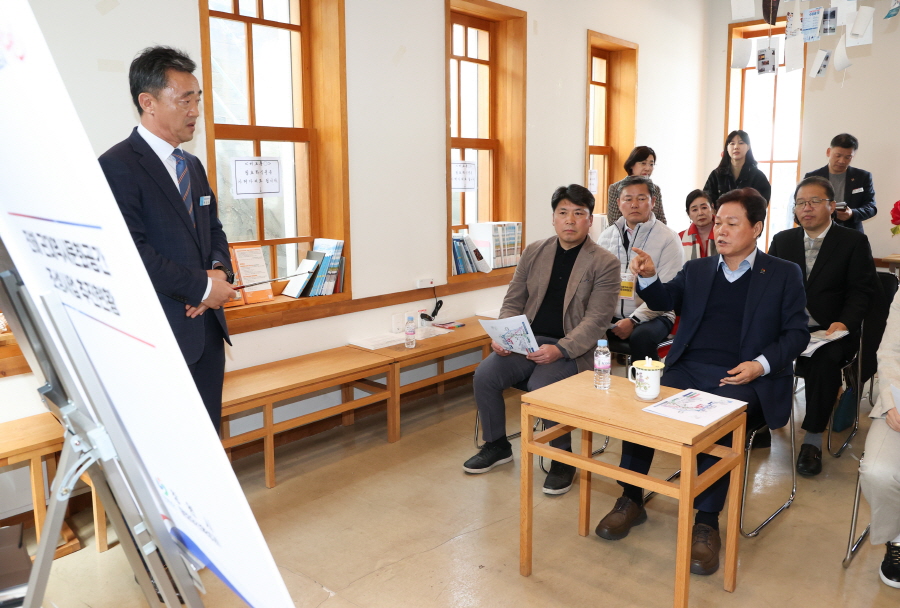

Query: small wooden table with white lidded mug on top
[519,371,746,608]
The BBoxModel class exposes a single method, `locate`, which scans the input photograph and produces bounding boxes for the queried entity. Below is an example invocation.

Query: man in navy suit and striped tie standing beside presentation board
[100,47,234,431]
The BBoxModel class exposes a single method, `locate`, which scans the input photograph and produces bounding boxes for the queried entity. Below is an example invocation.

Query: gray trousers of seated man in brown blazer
[473,336,578,451]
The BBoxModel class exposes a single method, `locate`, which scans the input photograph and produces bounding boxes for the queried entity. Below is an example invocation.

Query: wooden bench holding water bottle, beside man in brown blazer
[355,317,491,441]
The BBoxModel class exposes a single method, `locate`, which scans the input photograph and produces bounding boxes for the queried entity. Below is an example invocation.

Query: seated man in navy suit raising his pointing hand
[597,188,809,574]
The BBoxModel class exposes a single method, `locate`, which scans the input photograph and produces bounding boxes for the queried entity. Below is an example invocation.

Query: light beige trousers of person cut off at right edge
[859,417,900,545]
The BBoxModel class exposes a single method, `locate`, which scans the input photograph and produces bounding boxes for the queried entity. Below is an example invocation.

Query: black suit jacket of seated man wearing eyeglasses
[769,224,878,332]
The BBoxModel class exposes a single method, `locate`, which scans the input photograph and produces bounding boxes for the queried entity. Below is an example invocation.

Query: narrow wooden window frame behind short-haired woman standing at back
[584,30,638,213]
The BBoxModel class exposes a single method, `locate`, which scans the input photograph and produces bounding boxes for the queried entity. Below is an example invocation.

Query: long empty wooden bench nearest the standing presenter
[222,346,392,488]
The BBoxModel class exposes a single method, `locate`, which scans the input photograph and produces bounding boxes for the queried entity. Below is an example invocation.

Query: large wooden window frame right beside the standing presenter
[200,0,352,308]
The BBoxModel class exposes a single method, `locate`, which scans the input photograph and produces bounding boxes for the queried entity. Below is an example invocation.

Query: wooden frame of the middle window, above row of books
[444,0,528,291]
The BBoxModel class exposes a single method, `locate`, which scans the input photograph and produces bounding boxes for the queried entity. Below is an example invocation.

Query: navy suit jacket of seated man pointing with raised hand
[638,251,809,429]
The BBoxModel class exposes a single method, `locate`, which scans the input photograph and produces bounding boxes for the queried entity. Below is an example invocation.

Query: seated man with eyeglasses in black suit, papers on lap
[769,176,878,477]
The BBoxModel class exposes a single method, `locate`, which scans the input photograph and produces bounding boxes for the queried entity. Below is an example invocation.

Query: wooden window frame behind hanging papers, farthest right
[722,17,807,243]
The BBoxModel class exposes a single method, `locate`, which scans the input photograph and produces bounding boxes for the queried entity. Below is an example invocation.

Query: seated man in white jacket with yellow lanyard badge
[598,176,684,360]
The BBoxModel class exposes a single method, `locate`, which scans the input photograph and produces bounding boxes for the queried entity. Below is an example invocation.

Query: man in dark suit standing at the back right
[804,133,878,232]
